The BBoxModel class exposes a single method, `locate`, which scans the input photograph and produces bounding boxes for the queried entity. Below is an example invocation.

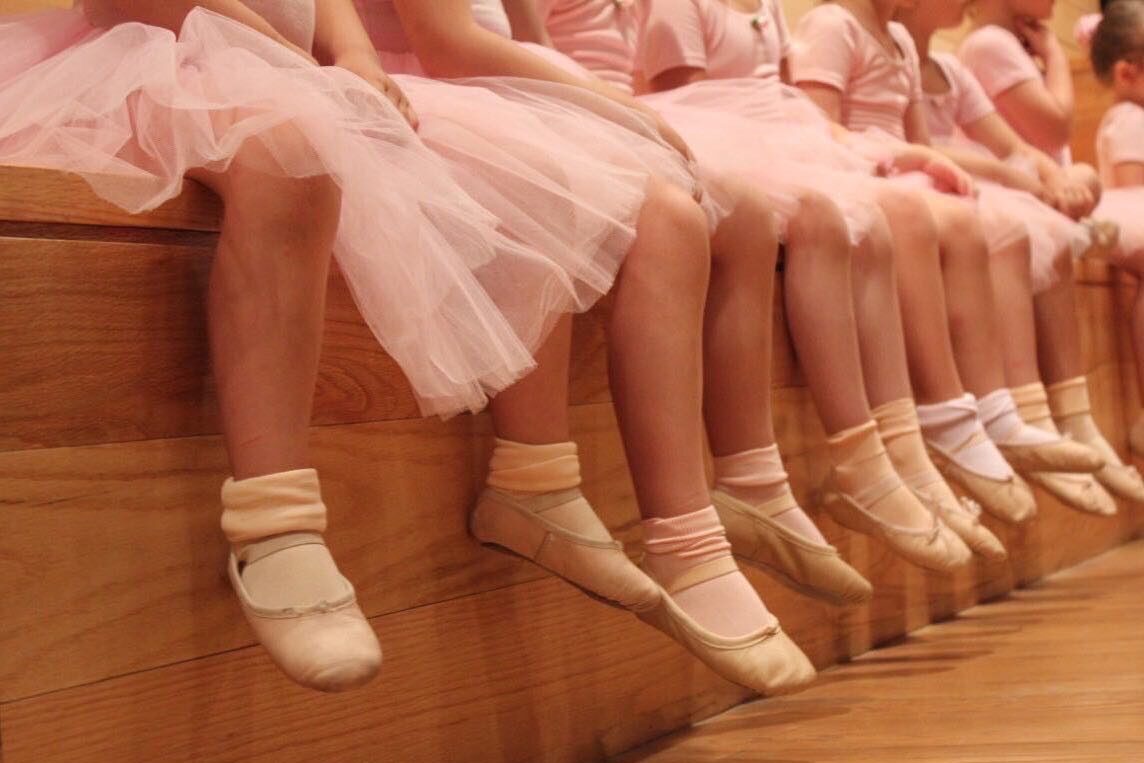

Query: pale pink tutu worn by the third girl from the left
[639,79,875,244]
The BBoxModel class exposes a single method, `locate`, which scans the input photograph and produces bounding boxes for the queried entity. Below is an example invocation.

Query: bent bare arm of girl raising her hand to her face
[993,22,1075,153]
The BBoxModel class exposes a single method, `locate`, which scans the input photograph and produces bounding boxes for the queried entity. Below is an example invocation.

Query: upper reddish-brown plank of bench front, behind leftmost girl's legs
[0,237,609,451]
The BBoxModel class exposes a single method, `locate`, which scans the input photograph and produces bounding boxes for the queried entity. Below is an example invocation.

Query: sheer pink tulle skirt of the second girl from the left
[379,46,725,236]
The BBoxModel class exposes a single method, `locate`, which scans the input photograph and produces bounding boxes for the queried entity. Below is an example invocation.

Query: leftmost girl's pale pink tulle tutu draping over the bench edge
[0,9,668,415]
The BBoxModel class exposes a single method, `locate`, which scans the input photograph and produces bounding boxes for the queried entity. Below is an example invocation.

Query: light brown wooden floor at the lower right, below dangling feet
[617,540,1144,763]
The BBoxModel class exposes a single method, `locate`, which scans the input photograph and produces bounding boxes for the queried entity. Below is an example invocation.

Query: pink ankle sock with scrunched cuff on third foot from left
[643,506,774,638]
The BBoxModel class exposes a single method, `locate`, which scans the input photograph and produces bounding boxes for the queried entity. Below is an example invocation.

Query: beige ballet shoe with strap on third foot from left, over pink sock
[637,556,816,696]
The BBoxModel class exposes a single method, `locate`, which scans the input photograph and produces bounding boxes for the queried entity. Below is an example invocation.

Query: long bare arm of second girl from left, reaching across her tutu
[394,0,691,158]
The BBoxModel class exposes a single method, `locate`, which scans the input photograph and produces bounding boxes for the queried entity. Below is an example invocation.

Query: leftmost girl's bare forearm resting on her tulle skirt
[313,0,418,128]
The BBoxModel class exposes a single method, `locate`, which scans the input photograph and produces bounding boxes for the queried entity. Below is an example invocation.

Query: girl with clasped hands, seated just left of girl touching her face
[898,0,1144,503]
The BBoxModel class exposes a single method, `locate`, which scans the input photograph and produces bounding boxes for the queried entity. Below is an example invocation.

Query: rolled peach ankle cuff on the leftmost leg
[222,469,326,545]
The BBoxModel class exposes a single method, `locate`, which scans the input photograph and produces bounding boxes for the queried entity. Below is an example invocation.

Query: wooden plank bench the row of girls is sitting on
[0,14,1142,763]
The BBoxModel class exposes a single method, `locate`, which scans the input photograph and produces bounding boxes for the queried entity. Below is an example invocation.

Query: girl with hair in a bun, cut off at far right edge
[1082,0,1144,453]
